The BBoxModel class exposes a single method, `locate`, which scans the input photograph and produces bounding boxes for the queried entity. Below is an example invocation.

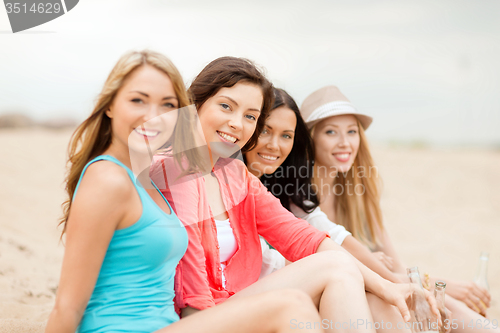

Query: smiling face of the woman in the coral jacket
[198,82,263,157]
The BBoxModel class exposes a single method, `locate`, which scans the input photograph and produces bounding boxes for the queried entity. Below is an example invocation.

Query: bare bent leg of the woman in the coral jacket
[231,251,375,333]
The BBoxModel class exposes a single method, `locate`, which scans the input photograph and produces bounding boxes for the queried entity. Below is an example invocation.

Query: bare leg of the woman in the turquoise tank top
[156,289,324,333]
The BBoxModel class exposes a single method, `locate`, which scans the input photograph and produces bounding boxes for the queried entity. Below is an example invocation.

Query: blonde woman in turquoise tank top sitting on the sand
[46,51,323,333]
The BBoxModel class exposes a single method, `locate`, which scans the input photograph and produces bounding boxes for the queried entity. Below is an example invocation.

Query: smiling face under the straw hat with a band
[313,115,360,172]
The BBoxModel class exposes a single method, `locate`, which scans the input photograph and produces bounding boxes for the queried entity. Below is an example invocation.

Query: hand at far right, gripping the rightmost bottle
[445,279,491,316]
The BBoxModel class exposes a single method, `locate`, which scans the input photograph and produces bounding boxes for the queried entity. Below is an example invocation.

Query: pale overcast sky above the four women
[0,0,500,146]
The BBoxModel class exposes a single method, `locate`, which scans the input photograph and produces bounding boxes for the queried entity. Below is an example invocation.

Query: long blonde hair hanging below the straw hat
[311,121,383,249]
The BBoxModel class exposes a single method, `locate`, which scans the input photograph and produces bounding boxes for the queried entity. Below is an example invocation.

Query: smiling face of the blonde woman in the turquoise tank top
[106,65,179,153]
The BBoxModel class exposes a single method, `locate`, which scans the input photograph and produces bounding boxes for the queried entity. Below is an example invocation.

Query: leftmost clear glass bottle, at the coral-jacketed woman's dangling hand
[406,267,438,333]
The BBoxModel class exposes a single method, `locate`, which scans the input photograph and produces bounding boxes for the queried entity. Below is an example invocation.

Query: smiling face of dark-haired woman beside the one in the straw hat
[245,106,297,177]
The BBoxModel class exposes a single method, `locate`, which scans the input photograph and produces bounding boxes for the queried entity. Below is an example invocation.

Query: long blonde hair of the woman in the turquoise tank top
[63,50,199,236]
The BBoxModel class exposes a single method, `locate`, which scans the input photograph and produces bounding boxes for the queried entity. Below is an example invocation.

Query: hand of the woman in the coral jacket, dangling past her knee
[377,282,443,326]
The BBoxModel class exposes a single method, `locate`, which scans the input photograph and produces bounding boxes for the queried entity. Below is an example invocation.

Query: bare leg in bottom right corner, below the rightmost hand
[445,295,500,333]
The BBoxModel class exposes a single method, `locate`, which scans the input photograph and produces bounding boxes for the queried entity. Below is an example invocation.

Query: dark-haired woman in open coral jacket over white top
[155,57,439,331]
